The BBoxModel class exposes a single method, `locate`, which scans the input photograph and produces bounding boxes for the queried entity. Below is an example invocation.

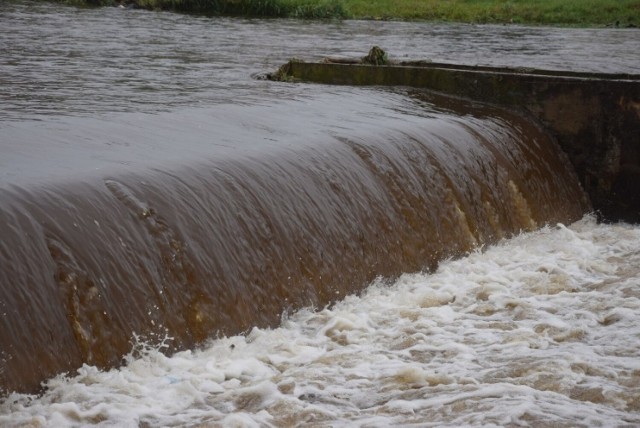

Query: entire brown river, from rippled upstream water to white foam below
[0,1,640,427]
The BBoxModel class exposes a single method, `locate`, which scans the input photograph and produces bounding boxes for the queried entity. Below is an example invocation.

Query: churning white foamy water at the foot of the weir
[0,218,640,427]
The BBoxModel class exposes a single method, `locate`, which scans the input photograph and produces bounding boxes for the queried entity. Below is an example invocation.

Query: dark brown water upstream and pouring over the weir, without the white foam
[0,2,639,390]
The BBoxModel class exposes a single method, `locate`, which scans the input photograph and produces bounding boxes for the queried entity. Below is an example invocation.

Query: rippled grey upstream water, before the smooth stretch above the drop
[0,1,640,121]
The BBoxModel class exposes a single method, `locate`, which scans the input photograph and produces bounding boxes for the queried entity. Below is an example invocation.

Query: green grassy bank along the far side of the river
[57,0,640,27]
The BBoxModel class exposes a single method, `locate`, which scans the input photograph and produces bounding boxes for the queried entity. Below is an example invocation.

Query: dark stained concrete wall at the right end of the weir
[277,57,640,223]
